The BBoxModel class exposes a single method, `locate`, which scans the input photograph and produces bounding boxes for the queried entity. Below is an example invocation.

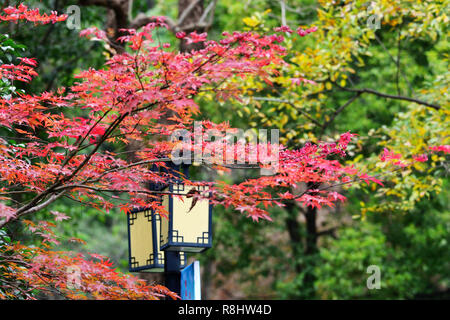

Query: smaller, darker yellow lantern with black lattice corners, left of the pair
[128,208,186,272]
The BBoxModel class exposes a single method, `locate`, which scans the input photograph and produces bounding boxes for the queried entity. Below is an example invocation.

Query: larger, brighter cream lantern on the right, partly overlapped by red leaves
[160,181,212,252]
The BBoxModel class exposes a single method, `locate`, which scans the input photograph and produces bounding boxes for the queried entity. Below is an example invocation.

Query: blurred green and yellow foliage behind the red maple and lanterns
[0,0,450,299]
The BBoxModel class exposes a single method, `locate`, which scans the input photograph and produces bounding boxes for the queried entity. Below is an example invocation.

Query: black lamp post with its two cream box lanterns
[128,162,212,296]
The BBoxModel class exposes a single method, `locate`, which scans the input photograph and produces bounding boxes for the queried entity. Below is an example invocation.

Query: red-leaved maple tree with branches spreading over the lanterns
[0,5,436,299]
